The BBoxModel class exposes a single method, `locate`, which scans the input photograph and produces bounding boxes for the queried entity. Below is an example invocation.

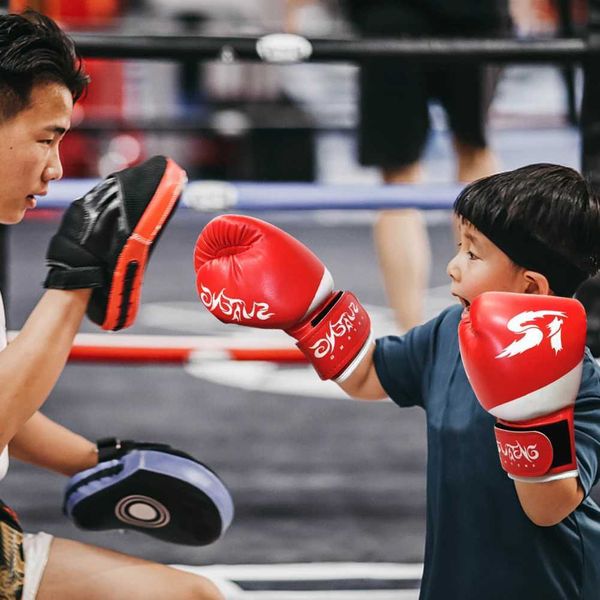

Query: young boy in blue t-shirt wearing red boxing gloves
[195,164,600,600]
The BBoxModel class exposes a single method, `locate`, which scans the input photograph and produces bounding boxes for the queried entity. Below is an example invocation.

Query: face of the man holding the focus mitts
[0,83,73,224]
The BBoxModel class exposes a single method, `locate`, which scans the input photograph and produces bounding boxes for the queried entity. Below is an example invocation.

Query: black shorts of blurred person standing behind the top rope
[355,2,508,168]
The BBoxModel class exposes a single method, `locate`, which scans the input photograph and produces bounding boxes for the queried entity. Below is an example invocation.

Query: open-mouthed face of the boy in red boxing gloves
[446,219,530,307]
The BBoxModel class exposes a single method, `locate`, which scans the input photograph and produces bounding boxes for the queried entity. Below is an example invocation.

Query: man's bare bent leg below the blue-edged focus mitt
[36,538,224,600]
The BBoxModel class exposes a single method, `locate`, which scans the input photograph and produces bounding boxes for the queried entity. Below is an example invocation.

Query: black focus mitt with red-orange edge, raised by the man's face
[44,156,187,331]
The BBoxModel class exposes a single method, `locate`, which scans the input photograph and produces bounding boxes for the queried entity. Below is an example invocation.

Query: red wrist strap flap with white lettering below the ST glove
[495,426,554,477]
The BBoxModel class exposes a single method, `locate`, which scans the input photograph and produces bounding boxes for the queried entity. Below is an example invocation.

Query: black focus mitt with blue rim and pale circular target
[63,438,233,546]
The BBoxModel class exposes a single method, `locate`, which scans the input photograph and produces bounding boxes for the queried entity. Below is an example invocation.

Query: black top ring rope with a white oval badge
[71,32,600,63]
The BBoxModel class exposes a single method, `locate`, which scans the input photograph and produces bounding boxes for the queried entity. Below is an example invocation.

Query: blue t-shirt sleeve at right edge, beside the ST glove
[575,350,600,496]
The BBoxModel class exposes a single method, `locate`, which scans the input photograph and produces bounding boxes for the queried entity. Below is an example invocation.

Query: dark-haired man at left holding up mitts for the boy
[0,13,222,600]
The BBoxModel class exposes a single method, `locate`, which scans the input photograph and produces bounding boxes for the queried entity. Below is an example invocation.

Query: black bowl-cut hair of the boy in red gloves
[454,163,600,295]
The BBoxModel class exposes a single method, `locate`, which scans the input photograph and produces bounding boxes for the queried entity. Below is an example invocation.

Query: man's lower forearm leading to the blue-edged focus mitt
[9,412,98,476]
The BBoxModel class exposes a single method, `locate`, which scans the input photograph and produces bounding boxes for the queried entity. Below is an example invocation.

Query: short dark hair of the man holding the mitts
[0,11,89,121]
